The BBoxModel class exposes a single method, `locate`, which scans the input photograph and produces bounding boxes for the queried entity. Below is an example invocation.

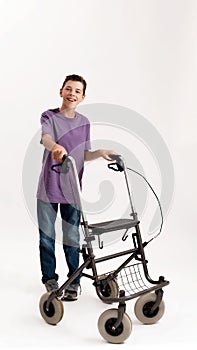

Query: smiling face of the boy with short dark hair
[60,80,85,109]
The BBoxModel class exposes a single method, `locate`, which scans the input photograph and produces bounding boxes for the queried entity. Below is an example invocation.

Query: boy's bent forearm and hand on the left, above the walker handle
[42,134,68,162]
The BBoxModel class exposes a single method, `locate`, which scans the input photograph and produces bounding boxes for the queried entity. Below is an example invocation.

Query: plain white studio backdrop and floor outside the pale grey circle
[0,0,197,349]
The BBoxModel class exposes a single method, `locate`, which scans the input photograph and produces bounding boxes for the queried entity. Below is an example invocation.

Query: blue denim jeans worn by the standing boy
[37,199,80,284]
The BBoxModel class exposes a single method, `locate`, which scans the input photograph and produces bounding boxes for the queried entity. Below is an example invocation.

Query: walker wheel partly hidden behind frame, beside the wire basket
[97,275,119,304]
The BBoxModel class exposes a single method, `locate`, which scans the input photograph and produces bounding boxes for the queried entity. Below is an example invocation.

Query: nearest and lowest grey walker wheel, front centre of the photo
[98,309,132,344]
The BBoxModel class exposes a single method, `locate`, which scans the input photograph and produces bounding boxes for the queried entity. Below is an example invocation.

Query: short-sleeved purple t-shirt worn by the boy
[37,108,91,203]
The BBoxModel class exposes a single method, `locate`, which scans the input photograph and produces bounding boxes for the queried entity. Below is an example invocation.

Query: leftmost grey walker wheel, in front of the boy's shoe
[39,293,64,325]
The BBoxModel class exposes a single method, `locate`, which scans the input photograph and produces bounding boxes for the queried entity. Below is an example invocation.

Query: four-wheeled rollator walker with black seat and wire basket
[39,155,169,343]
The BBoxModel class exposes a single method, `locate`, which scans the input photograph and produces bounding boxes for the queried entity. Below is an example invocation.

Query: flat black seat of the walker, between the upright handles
[88,219,139,235]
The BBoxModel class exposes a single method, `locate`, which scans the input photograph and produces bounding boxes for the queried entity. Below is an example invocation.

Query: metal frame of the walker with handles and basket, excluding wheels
[41,155,169,344]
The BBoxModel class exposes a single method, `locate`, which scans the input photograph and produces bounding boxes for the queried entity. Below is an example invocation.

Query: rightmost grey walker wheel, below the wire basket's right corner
[134,293,165,324]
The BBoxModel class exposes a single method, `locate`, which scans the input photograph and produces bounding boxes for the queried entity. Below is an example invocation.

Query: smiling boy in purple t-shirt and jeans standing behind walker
[37,74,113,301]
